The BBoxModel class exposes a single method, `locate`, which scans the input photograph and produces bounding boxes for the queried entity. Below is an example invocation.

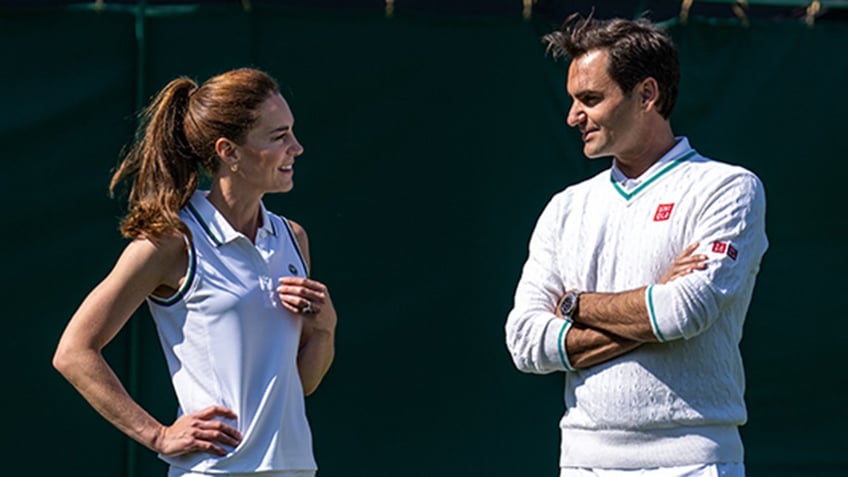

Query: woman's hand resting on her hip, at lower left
[154,406,241,456]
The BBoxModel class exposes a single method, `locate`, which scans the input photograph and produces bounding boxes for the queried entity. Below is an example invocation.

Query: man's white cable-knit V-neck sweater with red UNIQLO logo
[506,138,768,469]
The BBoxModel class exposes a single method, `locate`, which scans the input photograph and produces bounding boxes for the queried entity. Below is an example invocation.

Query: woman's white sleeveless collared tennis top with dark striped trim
[147,191,317,473]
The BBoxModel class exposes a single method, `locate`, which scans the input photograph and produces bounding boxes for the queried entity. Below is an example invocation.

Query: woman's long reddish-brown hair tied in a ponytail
[109,68,279,239]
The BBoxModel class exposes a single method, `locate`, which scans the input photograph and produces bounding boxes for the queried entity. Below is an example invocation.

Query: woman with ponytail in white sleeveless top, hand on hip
[53,69,336,477]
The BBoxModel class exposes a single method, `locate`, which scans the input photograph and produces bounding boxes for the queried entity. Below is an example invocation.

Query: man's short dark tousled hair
[543,14,680,119]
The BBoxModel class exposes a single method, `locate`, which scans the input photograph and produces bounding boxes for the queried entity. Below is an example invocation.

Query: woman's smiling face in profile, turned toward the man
[235,94,303,194]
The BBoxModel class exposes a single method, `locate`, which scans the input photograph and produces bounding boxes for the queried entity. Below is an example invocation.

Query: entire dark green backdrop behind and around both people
[0,7,848,477]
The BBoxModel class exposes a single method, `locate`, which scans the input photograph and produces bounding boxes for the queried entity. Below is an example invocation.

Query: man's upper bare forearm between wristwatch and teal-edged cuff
[571,287,658,343]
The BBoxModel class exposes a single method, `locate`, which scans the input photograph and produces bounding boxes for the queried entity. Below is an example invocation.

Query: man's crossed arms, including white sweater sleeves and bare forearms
[506,175,768,374]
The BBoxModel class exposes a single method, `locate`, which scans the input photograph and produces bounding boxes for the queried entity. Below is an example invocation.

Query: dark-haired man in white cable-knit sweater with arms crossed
[506,13,768,477]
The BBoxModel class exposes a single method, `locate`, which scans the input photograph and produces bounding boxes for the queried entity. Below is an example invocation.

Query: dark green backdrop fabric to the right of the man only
[672,17,848,475]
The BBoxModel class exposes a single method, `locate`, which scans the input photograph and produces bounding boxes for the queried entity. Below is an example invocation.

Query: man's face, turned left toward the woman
[567,50,642,159]
